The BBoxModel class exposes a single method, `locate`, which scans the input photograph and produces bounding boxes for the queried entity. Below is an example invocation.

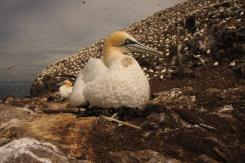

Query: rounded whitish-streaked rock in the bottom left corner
[0,138,69,163]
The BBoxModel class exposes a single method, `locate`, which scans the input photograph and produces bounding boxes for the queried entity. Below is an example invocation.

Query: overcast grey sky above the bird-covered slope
[0,0,183,81]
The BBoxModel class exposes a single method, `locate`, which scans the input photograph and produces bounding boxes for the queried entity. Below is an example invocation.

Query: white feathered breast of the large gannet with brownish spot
[83,55,150,108]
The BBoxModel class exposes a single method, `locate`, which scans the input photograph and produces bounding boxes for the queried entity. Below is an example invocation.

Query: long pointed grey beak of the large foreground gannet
[125,42,163,55]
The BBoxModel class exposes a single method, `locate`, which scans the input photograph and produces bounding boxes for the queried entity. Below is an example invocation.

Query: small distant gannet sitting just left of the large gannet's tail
[59,80,73,99]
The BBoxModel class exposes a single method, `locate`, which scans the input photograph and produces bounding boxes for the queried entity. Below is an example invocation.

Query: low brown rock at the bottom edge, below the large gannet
[111,150,180,163]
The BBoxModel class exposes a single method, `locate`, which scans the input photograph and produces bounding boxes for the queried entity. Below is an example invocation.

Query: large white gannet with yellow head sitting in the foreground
[69,31,162,108]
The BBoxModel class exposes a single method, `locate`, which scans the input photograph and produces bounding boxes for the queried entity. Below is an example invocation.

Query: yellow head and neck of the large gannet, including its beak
[103,31,162,66]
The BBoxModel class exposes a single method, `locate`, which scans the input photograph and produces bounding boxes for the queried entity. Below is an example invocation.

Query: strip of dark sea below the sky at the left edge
[0,81,32,100]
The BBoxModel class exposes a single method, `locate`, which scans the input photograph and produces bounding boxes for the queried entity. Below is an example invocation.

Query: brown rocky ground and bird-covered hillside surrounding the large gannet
[0,0,245,162]
